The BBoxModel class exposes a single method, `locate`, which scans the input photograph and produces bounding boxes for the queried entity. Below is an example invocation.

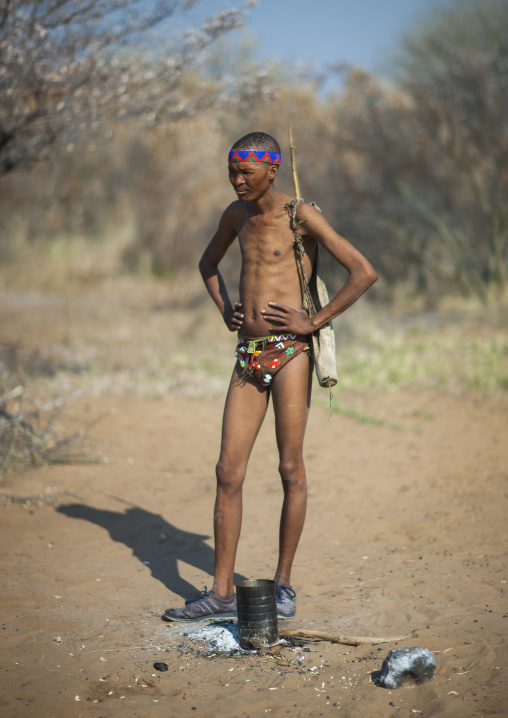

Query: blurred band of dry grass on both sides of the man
[0,236,508,422]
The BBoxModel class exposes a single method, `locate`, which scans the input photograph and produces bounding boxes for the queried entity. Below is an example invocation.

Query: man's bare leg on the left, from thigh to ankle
[212,365,269,599]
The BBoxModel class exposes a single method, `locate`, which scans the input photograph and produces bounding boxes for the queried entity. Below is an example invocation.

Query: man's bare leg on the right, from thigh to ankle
[272,352,312,586]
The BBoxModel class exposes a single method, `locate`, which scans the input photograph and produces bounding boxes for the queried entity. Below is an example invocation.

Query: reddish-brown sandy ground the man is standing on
[0,390,508,718]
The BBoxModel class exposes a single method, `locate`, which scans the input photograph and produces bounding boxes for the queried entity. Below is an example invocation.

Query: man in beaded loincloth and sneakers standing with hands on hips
[164,132,377,621]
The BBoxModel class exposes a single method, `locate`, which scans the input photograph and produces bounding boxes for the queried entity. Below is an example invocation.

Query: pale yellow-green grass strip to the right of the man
[336,302,508,395]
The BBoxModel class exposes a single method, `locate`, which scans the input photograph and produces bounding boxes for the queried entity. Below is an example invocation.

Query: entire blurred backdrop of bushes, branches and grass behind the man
[0,0,508,416]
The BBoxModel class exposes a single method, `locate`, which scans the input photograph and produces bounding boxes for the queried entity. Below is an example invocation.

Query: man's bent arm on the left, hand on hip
[199,202,243,332]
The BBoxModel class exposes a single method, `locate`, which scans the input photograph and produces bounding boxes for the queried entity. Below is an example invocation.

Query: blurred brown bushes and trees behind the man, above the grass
[0,0,508,307]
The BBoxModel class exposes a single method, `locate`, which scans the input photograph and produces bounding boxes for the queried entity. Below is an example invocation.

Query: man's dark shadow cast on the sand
[56,504,245,599]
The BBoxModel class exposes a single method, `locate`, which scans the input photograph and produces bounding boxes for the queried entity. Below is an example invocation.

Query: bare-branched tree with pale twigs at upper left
[0,0,259,174]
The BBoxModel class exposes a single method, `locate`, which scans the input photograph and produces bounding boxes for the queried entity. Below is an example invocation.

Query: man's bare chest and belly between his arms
[235,193,315,337]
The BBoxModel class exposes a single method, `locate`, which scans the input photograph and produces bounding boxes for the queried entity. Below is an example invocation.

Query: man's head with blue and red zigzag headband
[228,132,281,201]
